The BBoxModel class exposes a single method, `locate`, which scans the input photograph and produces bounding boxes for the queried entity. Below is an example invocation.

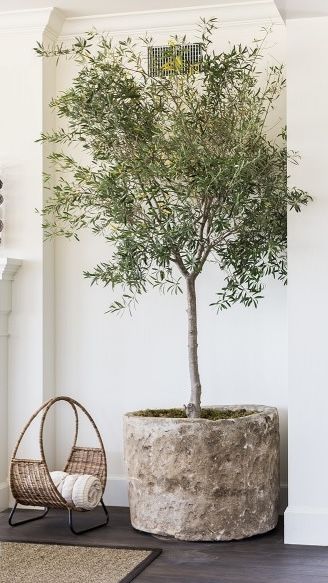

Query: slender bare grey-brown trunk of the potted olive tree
[186,276,202,419]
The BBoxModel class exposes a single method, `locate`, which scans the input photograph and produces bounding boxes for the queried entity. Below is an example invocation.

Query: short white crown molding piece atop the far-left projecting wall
[0,7,64,38]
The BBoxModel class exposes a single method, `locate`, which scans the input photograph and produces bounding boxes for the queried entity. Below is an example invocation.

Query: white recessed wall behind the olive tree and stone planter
[55,14,287,504]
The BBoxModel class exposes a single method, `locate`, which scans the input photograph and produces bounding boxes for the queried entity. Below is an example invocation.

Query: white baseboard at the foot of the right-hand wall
[285,506,328,546]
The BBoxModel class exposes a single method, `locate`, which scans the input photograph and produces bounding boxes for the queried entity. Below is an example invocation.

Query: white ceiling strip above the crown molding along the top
[0,0,328,18]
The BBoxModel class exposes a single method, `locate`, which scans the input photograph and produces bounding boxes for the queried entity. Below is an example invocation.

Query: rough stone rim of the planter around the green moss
[124,404,278,425]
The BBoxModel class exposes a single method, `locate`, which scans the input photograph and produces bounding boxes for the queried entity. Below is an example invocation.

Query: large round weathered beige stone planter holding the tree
[124,405,279,541]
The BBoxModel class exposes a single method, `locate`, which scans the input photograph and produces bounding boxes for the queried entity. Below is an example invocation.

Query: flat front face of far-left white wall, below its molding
[0,27,43,480]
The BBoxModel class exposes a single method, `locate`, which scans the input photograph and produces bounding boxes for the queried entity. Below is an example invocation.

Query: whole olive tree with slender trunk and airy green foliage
[36,20,310,417]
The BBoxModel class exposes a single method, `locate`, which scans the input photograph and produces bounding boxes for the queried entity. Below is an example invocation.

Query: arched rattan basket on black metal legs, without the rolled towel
[9,397,109,534]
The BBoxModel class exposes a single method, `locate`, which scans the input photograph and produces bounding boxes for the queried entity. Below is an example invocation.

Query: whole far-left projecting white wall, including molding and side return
[0,9,62,506]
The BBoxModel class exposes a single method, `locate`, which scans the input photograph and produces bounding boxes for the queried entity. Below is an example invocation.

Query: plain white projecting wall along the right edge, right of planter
[285,18,328,545]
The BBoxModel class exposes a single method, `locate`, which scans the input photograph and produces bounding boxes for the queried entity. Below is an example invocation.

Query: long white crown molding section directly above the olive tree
[60,0,282,38]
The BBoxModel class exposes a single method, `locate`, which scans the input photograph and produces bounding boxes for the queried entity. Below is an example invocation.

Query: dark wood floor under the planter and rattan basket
[0,508,328,583]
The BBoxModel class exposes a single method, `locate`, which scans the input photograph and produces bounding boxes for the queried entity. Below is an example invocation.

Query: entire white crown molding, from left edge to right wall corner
[0,0,282,40]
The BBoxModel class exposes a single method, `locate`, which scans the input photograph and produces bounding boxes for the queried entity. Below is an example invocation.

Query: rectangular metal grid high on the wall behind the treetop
[148,43,202,77]
